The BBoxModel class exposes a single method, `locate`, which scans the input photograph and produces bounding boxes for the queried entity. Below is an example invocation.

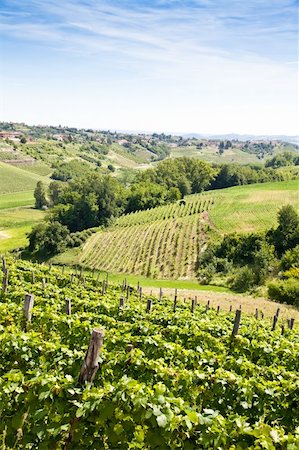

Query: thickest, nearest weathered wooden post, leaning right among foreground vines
[78,328,104,384]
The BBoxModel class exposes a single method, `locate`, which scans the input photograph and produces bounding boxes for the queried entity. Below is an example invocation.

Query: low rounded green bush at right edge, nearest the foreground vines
[268,278,299,306]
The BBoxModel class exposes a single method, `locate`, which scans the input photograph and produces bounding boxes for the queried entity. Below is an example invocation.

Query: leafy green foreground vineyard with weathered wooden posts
[0,260,299,450]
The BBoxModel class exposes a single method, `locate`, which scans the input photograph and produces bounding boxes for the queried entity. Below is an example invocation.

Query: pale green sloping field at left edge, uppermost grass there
[0,162,47,194]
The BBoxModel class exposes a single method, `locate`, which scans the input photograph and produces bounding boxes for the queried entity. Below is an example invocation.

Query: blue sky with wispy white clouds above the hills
[0,0,299,135]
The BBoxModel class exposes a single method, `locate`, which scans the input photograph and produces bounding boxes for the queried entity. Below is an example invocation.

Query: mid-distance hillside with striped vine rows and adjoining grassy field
[78,180,299,279]
